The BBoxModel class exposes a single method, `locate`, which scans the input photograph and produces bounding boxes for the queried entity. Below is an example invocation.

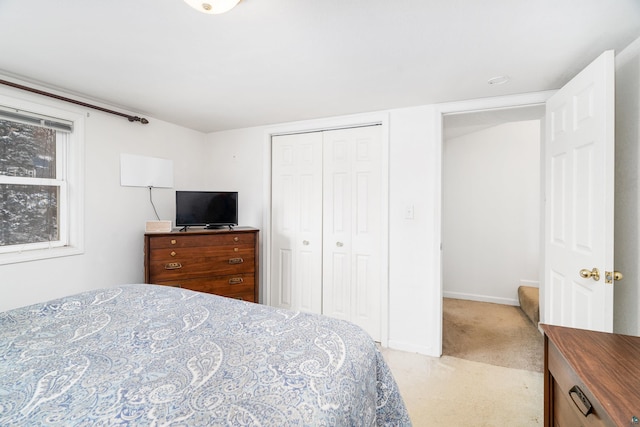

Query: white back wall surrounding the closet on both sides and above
[207,106,441,354]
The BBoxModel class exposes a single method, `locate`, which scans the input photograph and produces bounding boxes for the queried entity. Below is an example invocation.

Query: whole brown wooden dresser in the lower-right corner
[541,325,640,427]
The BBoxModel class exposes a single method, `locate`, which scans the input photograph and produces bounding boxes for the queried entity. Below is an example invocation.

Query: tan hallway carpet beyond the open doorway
[442,298,544,372]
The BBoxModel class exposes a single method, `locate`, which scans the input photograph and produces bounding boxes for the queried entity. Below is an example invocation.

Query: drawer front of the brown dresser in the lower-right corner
[548,344,607,427]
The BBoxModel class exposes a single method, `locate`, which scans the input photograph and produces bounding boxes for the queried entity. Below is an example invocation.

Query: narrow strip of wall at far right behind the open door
[613,38,640,335]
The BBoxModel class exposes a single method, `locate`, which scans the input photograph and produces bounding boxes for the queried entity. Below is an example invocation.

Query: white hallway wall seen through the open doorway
[442,120,540,305]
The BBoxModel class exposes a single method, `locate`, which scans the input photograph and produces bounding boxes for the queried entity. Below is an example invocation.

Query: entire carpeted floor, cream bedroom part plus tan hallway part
[382,299,544,427]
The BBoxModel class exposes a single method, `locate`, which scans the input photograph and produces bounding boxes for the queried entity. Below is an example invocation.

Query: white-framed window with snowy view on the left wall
[0,98,83,264]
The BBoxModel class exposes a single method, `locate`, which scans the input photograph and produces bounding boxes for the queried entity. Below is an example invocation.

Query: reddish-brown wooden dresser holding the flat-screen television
[144,227,259,302]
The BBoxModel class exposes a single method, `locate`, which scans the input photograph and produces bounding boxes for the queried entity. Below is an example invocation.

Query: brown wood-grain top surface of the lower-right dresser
[541,325,640,426]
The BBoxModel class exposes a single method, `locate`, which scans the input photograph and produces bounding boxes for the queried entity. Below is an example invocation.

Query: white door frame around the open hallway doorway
[432,91,556,356]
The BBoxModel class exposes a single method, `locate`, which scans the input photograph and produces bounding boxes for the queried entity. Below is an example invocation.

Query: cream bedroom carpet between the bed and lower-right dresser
[382,349,544,427]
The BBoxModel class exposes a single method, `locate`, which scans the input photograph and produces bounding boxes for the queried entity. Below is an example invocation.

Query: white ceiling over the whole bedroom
[0,0,640,132]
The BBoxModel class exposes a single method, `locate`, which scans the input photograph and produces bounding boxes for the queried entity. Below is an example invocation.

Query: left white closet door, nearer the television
[271,132,322,313]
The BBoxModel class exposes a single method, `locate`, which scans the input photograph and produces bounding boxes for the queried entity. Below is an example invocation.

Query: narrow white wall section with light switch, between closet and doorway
[389,106,442,356]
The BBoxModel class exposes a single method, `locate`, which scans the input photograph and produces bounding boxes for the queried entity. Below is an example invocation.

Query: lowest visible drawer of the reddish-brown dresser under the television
[158,273,255,302]
